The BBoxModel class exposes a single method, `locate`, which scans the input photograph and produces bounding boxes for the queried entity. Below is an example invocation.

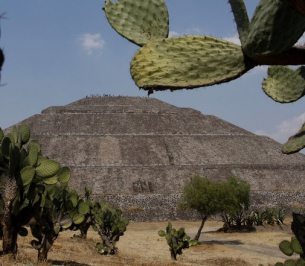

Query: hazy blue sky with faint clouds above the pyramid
[0,0,305,142]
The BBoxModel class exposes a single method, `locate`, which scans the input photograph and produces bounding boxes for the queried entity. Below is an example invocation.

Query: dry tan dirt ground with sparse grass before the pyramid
[0,221,292,266]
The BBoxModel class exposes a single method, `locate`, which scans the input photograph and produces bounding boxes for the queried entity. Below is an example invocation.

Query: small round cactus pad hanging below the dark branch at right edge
[263,66,305,103]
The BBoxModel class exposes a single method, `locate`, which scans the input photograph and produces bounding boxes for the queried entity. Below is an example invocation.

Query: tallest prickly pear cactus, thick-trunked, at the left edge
[0,125,70,260]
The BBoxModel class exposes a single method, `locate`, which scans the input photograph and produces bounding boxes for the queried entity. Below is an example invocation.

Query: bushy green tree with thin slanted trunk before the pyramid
[178,176,250,240]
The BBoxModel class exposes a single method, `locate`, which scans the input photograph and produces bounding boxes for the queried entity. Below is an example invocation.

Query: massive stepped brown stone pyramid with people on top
[8,96,305,221]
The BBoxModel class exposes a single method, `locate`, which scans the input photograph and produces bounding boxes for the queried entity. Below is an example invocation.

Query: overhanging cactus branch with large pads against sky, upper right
[104,0,305,153]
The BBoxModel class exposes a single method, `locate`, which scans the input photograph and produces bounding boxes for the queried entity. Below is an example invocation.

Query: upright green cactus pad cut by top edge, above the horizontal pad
[104,0,169,46]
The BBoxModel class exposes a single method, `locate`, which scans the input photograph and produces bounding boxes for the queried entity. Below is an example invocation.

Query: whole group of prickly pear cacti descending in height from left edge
[0,125,129,261]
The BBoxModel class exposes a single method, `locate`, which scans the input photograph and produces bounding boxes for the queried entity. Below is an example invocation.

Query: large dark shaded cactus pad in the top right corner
[243,0,305,57]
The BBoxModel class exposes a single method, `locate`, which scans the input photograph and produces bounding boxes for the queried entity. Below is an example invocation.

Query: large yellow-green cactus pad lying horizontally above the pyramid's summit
[130,36,252,90]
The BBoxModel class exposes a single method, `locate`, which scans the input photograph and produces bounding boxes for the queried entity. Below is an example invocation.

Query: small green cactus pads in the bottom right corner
[275,237,305,266]
